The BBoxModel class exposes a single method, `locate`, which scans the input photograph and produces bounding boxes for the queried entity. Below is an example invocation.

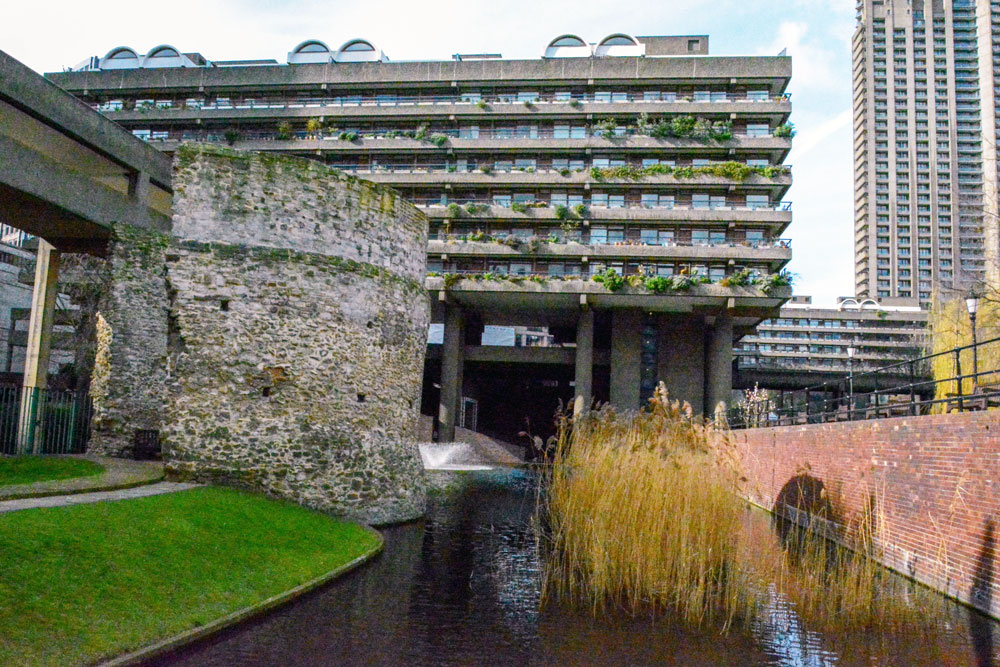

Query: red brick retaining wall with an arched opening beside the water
[731,412,1000,617]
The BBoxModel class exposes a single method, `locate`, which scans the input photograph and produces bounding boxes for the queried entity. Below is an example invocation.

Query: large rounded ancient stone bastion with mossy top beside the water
[164,146,429,523]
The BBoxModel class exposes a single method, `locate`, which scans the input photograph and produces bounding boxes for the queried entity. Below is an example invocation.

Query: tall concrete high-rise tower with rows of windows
[854,0,1000,305]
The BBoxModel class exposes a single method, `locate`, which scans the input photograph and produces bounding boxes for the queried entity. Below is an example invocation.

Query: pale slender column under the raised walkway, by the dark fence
[17,239,59,454]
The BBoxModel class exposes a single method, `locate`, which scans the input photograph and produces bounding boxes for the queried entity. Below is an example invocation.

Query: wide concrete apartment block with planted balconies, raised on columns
[48,34,791,440]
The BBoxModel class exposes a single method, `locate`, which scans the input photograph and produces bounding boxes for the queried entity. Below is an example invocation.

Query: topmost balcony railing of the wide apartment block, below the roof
[99,93,791,113]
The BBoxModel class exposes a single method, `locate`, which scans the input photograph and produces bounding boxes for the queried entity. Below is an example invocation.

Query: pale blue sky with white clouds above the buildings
[0,0,854,304]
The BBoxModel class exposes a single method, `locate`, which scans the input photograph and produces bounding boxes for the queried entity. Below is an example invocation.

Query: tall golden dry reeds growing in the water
[539,384,936,633]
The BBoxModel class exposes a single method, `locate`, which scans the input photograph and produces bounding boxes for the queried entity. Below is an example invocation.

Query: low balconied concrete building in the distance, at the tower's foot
[736,296,927,391]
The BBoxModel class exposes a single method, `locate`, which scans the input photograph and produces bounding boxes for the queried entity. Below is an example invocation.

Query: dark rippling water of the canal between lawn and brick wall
[159,470,1000,667]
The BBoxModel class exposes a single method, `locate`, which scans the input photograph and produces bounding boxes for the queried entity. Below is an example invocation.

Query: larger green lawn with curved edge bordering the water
[0,487,379,665]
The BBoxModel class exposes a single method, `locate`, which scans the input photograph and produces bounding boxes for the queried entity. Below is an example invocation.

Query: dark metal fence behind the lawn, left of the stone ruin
[0,385,92,454]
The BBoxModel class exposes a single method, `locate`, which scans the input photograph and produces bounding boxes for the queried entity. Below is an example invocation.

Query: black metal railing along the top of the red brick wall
[728,338,1000,428]
